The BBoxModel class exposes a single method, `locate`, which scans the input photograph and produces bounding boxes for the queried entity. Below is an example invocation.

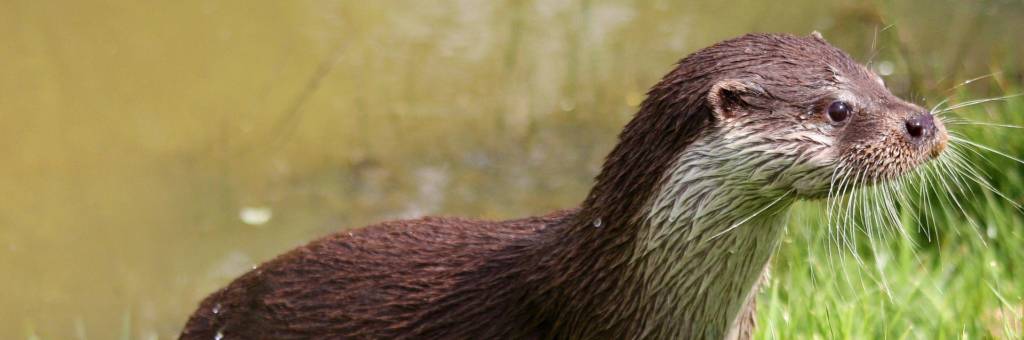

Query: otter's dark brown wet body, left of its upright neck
[182,211,574,339]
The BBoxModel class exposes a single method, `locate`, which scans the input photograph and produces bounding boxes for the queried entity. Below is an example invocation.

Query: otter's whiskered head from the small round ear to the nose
[700,34,947,198]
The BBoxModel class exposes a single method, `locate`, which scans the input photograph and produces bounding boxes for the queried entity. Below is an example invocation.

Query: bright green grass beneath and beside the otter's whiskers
[758,89,1024,339]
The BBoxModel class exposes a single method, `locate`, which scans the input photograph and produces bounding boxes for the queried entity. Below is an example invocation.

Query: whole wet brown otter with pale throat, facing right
[181,34,947,339]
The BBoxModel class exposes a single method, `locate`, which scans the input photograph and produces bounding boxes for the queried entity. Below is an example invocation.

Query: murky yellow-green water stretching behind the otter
[0,0,1024,339]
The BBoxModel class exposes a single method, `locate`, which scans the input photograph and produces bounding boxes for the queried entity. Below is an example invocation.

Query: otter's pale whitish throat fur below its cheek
[633,134,794,338]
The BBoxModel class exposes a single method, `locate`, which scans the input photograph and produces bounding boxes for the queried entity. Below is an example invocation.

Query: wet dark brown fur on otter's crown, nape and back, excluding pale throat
[181,35,937,339]
